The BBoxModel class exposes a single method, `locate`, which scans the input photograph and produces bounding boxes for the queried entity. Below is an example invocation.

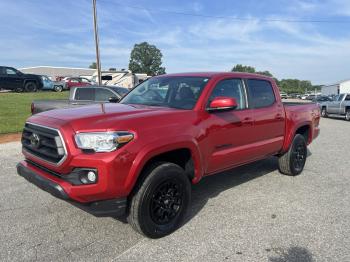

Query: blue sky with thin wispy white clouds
[0,0,350,84]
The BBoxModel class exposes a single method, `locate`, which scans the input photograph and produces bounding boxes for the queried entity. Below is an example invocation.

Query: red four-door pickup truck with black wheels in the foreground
[17,73,320,238]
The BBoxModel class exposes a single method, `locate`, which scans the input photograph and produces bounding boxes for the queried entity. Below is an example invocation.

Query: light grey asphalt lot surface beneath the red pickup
[0,119,350,262]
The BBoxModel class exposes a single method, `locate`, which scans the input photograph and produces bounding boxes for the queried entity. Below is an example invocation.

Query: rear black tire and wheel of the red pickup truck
[278,134,307,176]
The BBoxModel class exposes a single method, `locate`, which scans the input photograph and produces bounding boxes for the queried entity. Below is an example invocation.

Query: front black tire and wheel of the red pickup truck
[127,162,191,238]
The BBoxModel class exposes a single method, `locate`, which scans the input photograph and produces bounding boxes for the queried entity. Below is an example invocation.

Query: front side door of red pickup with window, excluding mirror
[203,78,253,174]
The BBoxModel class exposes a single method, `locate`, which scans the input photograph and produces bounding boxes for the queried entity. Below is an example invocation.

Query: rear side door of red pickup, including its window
[246,79,285,159]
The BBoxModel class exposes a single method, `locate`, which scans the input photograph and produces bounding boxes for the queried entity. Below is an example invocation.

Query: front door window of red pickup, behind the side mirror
[208,79,246,109]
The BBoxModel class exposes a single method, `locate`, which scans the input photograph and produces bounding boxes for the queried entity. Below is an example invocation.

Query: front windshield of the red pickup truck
[120,76,209,109]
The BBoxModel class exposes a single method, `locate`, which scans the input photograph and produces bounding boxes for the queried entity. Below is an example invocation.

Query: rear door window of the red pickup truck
[247,79,276,108]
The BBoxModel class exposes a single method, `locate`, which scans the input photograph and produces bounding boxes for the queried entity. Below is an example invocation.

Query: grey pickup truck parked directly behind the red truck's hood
[31,86,129,114]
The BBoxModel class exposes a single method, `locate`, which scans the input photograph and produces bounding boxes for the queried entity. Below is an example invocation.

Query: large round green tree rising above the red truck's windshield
[129,42,165,76]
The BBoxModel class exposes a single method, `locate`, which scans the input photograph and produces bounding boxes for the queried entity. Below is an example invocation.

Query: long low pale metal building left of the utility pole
[19,66,96,79]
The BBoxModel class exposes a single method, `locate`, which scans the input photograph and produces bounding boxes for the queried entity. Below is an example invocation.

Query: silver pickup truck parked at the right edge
[320,94,350,121]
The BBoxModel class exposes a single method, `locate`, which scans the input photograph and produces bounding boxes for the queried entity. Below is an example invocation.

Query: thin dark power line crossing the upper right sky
[103,0,350,24]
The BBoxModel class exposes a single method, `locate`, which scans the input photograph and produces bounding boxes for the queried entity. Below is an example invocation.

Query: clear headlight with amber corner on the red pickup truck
[75,132,134,152]
